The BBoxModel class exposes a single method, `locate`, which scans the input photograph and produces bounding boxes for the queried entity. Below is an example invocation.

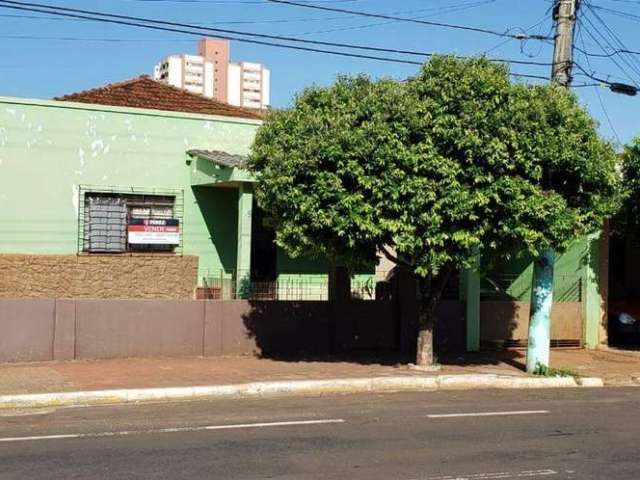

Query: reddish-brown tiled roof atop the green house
[55,75,262,119]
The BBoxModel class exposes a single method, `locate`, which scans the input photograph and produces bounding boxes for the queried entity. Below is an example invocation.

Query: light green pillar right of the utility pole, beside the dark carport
[582,233,602,348]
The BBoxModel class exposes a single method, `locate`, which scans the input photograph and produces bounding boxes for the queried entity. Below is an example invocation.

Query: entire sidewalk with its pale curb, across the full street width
[0,350,640,408]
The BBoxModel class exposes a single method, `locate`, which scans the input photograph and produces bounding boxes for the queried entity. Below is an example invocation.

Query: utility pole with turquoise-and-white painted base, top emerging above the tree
[527,0,580,373]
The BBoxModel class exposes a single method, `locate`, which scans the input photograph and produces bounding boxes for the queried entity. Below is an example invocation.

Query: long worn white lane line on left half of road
[0,418,345,443]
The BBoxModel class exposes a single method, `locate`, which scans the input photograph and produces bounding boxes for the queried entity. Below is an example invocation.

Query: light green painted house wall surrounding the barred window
[0,97,259,280]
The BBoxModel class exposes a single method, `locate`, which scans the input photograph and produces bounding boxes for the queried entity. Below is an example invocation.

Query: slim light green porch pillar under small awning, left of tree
[236,183,253,298]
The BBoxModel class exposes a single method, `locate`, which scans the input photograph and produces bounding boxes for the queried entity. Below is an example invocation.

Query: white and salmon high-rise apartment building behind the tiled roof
[154,38,271,109]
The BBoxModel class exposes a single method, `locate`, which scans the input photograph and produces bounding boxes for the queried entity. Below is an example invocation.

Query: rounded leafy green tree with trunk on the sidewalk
[249,57,616,365]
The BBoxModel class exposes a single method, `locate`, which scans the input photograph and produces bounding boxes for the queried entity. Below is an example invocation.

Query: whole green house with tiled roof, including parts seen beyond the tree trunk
[0,77,608,351]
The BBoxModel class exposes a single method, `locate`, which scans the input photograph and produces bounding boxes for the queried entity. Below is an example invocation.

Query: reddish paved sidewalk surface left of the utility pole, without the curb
[0,350,524,395]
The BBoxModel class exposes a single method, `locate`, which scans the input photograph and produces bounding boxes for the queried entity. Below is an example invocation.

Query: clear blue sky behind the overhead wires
[0,0,640,143]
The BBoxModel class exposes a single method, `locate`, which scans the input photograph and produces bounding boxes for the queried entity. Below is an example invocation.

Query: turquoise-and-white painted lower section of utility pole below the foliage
[527,248,556,373]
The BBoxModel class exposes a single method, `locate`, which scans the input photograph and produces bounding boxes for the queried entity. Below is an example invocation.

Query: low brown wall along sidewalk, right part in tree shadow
[0,299,393,362]
